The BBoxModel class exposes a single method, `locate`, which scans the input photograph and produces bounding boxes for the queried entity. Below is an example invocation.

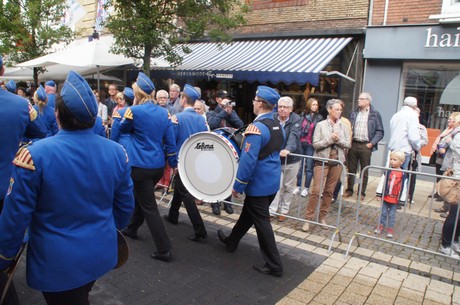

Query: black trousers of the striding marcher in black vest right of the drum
[227,194,283,272]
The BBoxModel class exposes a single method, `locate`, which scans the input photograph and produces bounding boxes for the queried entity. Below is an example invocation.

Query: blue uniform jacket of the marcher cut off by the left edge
[0,90,46,199]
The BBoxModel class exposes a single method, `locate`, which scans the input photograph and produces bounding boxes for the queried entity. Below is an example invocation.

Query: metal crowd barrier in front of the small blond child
[344,165,460,259]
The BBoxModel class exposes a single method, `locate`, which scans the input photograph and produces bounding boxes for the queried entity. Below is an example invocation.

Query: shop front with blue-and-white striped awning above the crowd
[151,37,359,122]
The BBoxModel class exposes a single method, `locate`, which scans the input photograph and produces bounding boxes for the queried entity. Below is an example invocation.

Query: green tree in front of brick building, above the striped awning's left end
[105,0,248,74]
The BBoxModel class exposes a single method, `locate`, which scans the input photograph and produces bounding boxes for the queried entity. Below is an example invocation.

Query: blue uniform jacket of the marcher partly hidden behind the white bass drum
[171,107,208,152]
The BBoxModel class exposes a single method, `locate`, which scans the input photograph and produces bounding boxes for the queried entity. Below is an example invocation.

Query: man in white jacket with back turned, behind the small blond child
[377,96,421,201]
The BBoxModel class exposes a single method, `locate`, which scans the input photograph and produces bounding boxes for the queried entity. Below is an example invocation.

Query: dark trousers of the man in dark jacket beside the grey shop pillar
[346,141,372,196]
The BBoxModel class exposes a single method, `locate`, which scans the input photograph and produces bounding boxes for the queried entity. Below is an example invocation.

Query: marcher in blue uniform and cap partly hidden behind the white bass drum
[165,84,208,241]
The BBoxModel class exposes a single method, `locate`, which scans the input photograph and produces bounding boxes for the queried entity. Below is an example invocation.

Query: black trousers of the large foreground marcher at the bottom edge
[42,281,96,305]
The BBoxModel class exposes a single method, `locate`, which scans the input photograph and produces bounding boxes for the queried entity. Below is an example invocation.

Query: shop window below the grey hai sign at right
[402,64,460,130]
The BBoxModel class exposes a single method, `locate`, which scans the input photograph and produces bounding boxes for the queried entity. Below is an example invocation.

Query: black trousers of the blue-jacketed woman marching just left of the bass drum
[128,167,171,252]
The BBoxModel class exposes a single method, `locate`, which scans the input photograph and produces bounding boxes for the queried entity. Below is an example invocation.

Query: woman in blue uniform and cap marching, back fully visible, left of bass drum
[120,72,177,261]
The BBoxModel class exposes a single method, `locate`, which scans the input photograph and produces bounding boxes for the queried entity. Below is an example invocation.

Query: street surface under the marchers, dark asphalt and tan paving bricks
[10,177,460,305]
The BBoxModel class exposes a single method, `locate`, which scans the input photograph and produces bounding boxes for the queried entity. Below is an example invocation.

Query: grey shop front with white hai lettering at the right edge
[363,24,460,164]
